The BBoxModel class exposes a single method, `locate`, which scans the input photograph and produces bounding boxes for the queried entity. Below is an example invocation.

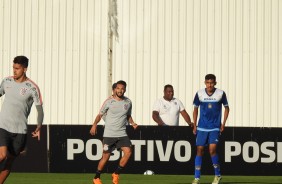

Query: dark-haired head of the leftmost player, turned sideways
[13,56,28,80]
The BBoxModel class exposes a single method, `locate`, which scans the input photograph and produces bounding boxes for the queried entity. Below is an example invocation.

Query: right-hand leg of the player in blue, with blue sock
[209,131,221,184]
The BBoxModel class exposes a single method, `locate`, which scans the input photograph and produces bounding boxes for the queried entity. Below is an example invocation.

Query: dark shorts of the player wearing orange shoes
[103,136,132,153]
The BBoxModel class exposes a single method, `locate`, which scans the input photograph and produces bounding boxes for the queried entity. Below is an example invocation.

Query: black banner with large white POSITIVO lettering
[50,125,282,175]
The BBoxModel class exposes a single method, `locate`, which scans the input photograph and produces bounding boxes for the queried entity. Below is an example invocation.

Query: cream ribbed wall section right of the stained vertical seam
[113,0,282,127]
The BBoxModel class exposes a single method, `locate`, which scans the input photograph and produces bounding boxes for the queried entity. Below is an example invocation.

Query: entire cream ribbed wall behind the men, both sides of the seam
[0,0,282,127]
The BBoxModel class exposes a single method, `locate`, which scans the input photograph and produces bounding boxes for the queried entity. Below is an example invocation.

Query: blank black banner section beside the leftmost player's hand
[12,125,48,173]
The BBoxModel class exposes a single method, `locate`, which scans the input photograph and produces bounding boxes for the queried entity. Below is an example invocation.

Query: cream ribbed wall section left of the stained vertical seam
[0,0,108,124]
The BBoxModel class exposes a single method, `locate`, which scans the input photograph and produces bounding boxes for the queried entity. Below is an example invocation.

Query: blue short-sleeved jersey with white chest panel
[193,88,228,131]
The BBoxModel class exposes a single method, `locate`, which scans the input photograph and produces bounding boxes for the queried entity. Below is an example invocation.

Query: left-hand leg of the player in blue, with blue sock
[192,131,208,184]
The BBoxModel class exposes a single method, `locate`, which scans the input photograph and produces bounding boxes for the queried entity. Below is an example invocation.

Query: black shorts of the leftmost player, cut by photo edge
[0,128,27,156]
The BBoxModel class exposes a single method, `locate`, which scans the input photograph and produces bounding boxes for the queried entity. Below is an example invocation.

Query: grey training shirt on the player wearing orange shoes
[100,97,132,137]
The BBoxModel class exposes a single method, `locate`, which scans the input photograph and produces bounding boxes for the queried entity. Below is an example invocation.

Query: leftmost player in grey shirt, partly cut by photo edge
[0,56,44,184]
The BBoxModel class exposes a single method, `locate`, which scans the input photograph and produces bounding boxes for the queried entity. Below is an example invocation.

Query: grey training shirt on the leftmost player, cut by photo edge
[0,77,42,134]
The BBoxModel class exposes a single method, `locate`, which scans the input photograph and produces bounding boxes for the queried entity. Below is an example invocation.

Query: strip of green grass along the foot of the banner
[5,173,282,184]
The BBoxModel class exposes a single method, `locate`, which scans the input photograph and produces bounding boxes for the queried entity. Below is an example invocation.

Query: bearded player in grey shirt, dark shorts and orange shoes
[90,81,137,184]
